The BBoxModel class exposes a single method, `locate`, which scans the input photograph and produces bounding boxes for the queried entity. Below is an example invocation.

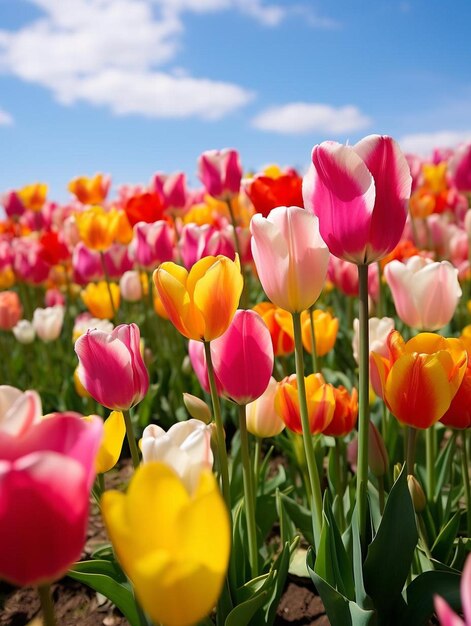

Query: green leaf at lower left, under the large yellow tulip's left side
[67,559,141,626]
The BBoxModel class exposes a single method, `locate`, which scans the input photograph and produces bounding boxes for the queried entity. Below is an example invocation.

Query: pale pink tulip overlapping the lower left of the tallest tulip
[250,207,329,313]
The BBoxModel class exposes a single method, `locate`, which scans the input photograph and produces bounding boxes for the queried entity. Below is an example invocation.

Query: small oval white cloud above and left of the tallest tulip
[252,102,371,135]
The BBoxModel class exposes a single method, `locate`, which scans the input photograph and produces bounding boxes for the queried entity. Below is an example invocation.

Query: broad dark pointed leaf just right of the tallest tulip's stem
[363,467,418,624]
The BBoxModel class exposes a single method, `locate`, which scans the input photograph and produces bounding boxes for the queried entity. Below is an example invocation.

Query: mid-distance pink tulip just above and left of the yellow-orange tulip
[129,220,174,271]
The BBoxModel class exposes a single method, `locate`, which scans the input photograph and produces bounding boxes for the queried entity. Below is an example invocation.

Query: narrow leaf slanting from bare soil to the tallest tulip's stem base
[306,548,377,626]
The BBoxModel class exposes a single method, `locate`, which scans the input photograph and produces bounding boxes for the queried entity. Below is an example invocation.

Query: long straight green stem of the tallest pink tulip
[356,265,370,547]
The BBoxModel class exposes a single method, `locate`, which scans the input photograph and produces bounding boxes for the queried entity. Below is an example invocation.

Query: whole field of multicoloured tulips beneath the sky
[0,135,471,626]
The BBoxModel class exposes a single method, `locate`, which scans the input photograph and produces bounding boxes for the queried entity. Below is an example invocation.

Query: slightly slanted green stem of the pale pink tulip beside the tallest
[292,312,322,551]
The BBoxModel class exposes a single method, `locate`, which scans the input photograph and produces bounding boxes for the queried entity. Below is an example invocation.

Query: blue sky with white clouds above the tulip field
[0,0,471,200]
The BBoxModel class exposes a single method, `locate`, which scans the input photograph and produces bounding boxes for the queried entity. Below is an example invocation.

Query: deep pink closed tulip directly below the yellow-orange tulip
[211,310,274,404]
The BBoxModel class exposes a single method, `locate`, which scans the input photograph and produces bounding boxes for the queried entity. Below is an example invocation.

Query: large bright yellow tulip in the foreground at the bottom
[102,462,230,626]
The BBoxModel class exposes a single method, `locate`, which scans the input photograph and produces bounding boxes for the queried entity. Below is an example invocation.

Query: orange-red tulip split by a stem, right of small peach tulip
[275,374,335,435]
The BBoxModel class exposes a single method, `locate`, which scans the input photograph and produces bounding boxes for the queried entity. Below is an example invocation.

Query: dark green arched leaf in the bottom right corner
[400,571,461,626]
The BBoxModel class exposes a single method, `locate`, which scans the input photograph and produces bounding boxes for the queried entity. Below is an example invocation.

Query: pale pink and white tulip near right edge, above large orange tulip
[384,256,461,330]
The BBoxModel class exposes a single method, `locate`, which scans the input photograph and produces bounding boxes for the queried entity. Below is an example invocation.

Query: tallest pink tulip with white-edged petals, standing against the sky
[303,135,412,265]
